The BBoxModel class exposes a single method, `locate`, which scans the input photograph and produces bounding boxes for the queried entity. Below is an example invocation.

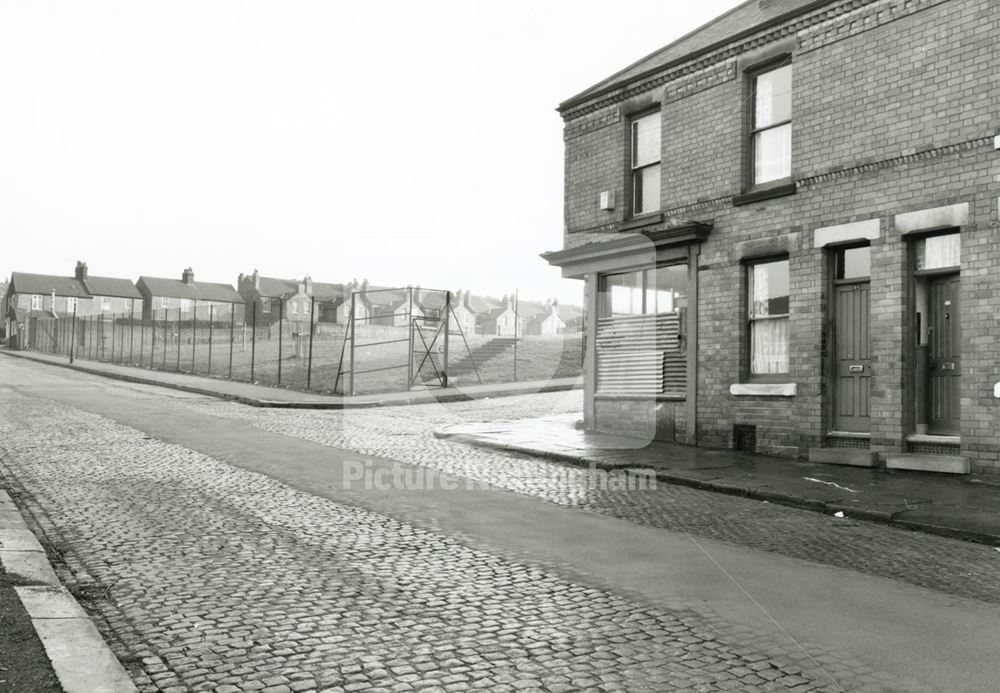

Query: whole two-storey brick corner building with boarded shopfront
[543,0,1000,471]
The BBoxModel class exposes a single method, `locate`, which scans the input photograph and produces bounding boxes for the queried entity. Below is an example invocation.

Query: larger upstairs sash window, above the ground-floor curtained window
[750,65,792,185]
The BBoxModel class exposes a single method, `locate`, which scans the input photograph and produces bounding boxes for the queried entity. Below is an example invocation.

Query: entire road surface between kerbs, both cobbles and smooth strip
[0,359,1000,691]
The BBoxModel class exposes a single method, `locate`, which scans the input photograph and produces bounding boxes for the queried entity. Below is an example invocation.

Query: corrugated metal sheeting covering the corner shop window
[596,313,687,396]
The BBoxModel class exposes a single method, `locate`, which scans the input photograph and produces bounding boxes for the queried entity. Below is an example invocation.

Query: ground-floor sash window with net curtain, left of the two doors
[747,258,789,376]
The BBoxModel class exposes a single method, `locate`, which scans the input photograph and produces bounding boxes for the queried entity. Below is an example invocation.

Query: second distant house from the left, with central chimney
[136,267,243,322]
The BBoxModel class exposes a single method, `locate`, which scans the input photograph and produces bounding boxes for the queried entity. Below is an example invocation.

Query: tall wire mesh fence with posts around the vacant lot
[19,287,583,394]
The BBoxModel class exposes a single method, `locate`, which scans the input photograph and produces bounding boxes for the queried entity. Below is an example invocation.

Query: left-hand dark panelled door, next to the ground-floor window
[833,281,871,432]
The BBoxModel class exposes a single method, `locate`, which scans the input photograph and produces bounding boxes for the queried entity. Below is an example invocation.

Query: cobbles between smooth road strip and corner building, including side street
[177,391,1000,604]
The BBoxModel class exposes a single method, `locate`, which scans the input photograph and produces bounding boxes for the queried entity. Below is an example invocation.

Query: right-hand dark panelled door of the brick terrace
[927,275,962,435]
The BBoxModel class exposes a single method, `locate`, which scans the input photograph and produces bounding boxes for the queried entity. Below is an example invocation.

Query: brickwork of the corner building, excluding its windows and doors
[564,0,1000,470]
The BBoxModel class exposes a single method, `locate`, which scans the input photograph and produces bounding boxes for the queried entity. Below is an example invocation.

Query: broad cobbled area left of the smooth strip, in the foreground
[0,388,892,693]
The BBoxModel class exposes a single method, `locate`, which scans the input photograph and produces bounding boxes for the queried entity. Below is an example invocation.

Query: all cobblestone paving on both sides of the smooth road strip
[0,364,1000,692]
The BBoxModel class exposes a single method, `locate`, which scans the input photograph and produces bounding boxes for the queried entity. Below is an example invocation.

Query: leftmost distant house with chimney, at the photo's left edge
[3,262,142,349]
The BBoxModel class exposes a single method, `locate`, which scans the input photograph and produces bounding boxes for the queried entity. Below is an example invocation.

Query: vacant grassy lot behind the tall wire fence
[36,320,583,394]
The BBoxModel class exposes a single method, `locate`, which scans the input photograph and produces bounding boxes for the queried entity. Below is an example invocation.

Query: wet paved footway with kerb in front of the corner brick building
[435,415,1000,545]
